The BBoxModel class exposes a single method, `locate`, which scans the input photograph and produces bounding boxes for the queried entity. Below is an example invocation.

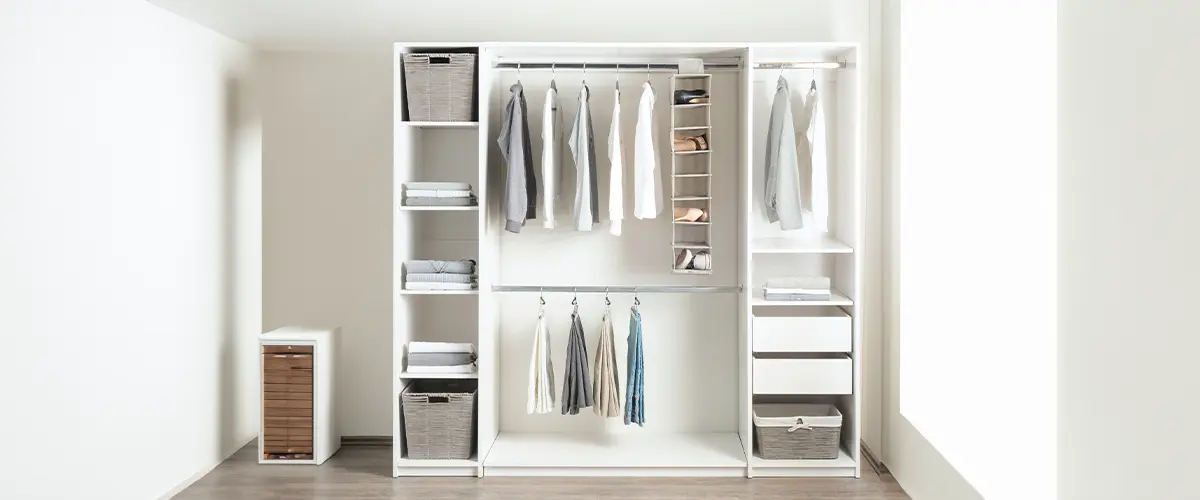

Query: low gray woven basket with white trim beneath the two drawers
[754,404,841,460]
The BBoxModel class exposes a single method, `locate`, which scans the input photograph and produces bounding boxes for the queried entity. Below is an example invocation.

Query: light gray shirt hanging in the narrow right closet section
[763,77,804,229]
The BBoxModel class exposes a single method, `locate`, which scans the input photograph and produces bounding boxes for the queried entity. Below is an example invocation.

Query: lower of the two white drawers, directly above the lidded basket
[754,356,854,394]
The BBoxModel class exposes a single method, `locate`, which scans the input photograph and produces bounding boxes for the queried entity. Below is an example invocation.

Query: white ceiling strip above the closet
[148,0,869,50]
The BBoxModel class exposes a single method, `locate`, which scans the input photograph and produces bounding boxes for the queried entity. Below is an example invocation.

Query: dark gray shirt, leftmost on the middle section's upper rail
[496,82,538,233]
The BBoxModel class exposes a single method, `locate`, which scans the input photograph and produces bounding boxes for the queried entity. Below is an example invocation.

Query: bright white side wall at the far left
[0,0,260,499]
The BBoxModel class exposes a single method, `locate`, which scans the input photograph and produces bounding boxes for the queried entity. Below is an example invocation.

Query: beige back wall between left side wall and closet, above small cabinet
[256,47,392,435]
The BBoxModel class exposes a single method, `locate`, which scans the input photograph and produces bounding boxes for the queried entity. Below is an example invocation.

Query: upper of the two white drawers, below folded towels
[752,307,853,353]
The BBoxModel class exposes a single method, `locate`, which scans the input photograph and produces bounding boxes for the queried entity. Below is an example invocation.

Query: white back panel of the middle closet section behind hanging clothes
[488,68,742,433]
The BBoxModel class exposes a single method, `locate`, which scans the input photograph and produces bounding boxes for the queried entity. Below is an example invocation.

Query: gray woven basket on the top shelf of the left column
[404,53,475,121]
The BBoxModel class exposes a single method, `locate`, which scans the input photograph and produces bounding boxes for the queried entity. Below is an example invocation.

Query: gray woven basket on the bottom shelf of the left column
[400,380,476,459]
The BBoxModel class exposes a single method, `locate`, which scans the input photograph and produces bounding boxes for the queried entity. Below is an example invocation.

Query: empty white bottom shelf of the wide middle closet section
[484,433,746,477]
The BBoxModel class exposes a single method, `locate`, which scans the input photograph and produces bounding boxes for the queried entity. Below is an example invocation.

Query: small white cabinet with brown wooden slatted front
[258,327,341,464]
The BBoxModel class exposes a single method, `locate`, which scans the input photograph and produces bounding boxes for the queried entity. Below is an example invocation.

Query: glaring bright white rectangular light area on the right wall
[899,0,1056,500]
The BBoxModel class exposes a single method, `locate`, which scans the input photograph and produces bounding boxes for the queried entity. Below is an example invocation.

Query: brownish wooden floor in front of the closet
[175,442,908,500]
